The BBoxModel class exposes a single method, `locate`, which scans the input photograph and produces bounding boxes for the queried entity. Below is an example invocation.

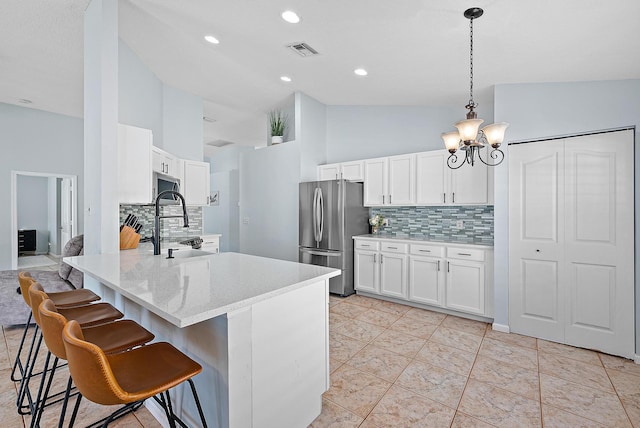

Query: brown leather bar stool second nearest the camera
[31,299,155,427]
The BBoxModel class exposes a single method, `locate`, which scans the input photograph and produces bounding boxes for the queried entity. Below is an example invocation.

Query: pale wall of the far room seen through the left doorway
[16,175,49,254]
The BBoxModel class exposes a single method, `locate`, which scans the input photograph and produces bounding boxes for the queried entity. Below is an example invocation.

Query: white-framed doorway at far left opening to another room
[11,171,78,269]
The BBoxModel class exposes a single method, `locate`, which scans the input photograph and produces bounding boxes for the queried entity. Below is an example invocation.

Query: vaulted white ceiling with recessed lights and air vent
[0,0,640,155]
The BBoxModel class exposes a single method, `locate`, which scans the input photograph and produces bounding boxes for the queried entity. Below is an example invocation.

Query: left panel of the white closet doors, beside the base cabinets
[509,142,565,342]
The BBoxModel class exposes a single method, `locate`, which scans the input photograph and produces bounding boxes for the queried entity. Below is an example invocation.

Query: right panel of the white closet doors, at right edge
[565,131,634,357]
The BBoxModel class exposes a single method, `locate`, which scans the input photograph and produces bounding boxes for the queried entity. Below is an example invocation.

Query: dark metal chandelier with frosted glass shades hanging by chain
[442,7,509,169]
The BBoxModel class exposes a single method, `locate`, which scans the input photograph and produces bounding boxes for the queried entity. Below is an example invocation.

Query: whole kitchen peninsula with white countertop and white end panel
[64,250,340,428]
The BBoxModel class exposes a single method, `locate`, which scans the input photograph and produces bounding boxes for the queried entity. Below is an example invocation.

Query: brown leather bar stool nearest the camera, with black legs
[62,321,207,427]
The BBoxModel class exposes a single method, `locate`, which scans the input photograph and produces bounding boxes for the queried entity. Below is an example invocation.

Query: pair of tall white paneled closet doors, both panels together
[509,131,635,358]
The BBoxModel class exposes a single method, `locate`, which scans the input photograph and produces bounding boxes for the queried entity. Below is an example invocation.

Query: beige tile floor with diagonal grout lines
[0,295,640,428]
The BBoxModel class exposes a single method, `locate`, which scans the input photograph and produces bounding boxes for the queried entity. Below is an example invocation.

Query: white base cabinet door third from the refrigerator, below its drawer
[409,256,444,306]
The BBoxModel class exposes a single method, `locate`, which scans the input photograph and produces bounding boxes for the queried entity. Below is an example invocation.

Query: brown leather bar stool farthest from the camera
[11,271,100,382]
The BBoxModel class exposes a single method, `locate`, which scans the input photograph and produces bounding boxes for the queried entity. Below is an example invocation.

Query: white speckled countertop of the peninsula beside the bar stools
[64,251,340,327]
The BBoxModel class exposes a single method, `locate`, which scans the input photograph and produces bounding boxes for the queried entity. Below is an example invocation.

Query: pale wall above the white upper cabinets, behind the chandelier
[326,105,470,163]
